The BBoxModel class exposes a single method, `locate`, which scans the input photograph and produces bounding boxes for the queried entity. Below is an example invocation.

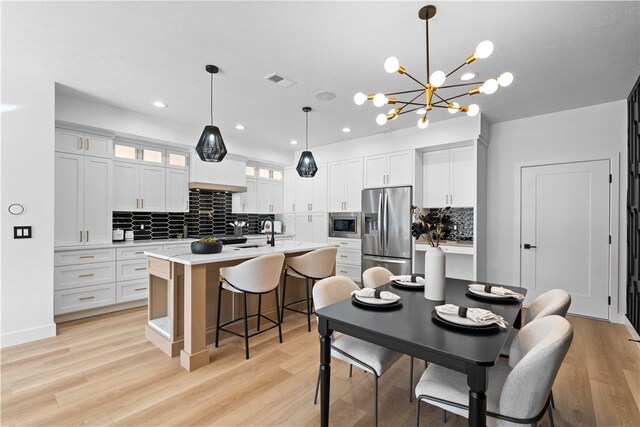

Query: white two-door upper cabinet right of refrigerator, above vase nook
[422,146,476,208]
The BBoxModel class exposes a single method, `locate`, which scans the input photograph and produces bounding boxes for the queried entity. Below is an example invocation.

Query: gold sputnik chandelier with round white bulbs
[353,5,513,129]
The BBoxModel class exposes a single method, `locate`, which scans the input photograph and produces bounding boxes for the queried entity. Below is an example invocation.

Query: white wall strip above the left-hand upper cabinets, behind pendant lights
[56,94,291,165]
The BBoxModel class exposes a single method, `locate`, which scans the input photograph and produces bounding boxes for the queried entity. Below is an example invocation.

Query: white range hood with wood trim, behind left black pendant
[189,150,247,193]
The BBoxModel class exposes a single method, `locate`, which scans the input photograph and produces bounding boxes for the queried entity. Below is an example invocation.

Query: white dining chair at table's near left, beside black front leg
[313,276,402,425]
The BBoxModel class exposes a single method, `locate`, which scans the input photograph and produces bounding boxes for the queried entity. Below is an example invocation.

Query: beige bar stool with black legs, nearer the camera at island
[216,254,284,359]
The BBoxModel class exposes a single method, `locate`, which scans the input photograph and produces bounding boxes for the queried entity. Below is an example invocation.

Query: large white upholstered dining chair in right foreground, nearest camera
[416,315,573,427]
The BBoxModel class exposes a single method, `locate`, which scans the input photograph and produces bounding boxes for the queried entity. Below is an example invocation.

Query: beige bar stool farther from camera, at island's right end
[280,247,338,332]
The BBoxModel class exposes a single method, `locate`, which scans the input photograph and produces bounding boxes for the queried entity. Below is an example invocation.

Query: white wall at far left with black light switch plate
[0,67,56,347]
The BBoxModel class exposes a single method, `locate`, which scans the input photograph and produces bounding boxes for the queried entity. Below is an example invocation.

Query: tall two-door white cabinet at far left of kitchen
[54,152,113,246]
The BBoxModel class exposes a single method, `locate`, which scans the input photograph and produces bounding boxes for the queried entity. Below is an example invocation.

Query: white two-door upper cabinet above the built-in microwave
[327,158,363,212]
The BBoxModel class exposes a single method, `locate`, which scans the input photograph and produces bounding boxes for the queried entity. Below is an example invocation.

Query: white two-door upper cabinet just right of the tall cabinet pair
[113,160,166,212]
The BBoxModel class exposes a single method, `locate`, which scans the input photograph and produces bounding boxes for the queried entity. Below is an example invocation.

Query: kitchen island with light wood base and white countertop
[145,240,330,371]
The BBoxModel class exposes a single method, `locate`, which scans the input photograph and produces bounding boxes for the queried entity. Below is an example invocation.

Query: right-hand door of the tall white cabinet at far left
[84,157,113,245]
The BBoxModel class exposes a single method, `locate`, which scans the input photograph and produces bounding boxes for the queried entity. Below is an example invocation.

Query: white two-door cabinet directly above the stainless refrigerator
[363,150,413,188]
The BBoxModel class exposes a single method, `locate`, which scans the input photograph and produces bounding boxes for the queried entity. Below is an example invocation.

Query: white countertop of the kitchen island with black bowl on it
[144,241,335,265]
